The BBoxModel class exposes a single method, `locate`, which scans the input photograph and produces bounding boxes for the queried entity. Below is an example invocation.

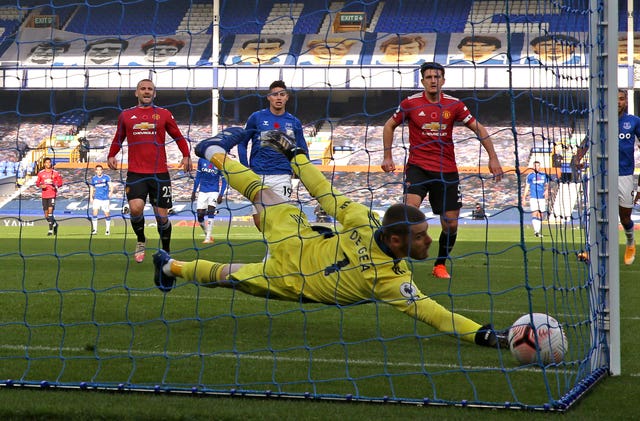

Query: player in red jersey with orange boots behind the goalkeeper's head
[382,63,502,279]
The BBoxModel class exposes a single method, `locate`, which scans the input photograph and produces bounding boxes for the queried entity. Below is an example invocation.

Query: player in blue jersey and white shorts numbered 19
[238,80,309,228]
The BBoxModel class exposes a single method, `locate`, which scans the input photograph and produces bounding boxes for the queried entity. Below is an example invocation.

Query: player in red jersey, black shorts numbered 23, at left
[107,79,191,263]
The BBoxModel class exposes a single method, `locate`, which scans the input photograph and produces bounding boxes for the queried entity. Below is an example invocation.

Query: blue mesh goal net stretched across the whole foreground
[0,0,624,410]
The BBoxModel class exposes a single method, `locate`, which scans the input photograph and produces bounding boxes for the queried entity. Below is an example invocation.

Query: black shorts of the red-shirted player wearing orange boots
[404,165,462,215]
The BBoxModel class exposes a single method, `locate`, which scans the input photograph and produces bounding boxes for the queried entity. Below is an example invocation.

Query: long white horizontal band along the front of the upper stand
[0,65,640,90]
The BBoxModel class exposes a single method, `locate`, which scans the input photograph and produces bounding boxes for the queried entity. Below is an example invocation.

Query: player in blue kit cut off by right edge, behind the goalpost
[575,89,640,265]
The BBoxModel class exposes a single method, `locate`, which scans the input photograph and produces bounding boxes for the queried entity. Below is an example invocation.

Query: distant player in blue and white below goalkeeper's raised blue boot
[191,158,227,244]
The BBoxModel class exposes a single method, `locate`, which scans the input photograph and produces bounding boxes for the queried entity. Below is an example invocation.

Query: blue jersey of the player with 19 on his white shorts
[238,108,309,175]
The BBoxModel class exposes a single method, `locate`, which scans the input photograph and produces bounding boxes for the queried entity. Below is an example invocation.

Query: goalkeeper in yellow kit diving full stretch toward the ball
[153,127,506,347]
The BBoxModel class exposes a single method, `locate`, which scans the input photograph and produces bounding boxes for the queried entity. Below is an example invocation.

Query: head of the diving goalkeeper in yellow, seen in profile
[381,203,432,260]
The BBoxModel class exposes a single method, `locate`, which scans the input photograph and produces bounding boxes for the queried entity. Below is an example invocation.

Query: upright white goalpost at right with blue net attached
[588,0,621,375]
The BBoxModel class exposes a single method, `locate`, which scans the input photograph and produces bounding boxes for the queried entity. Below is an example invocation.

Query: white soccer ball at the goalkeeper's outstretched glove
[508,313,568,365]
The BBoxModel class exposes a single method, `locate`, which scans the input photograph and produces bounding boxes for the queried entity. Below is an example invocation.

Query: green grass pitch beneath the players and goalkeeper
[0,221,640,414]
